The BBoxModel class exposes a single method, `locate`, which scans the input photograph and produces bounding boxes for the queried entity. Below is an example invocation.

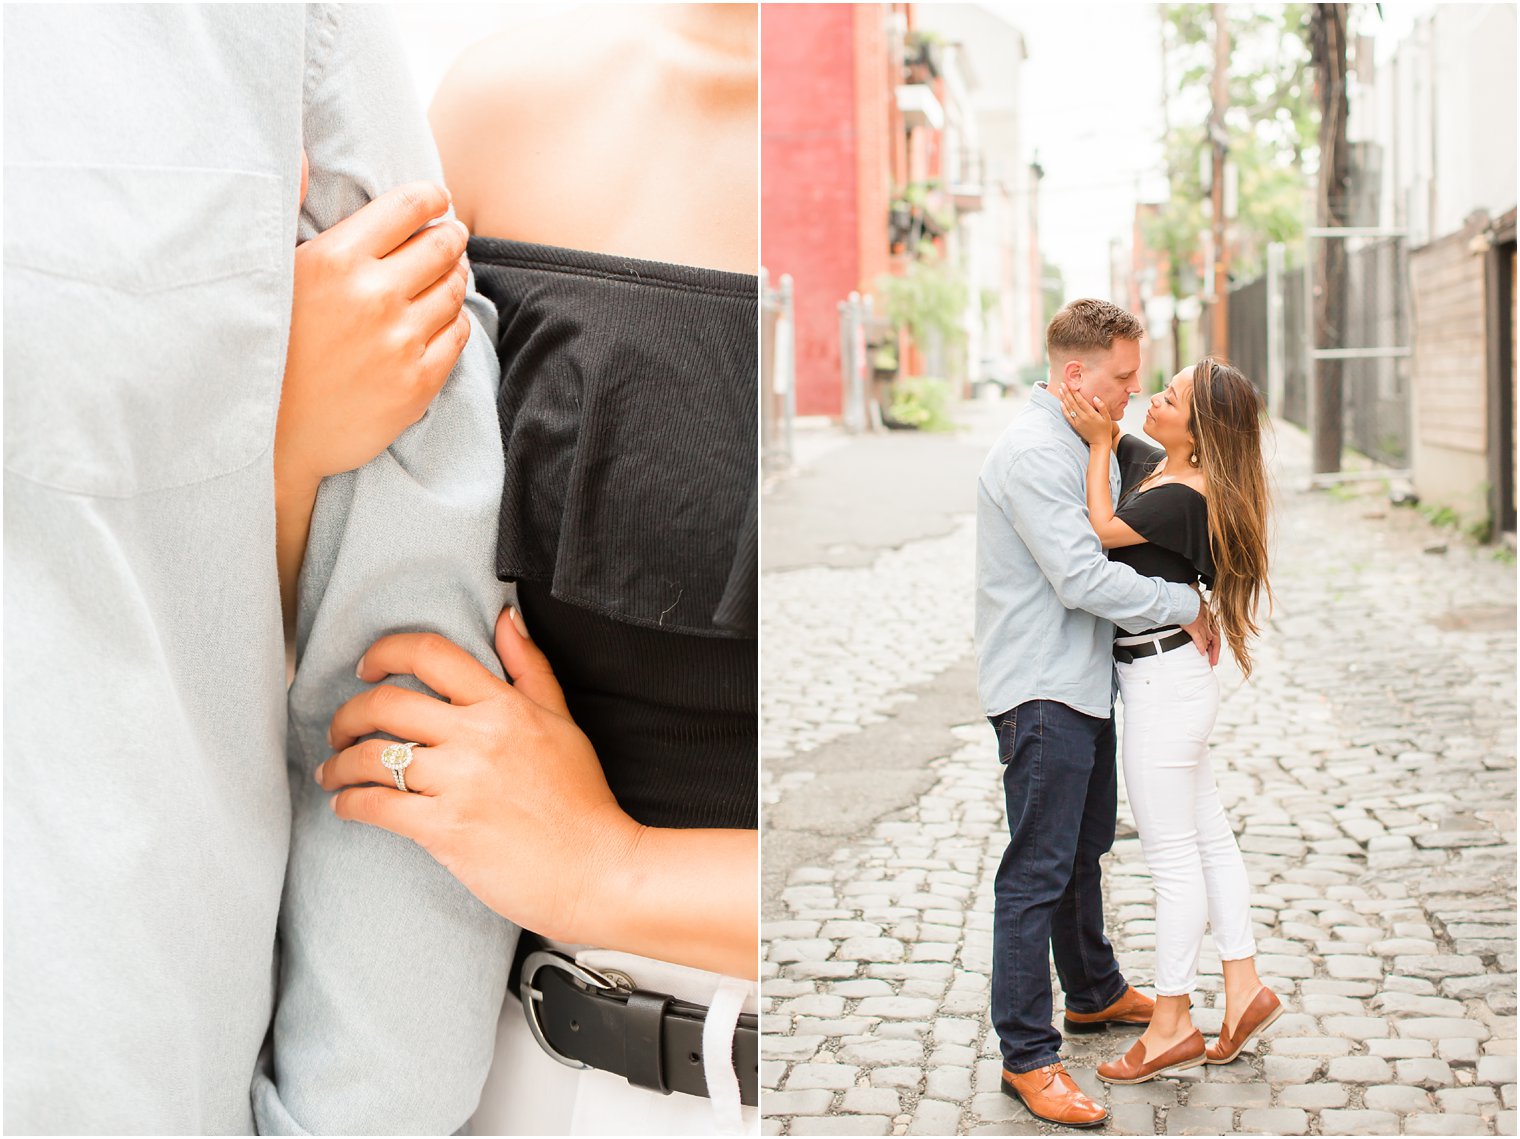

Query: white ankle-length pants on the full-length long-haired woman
[1117,636,1256,996]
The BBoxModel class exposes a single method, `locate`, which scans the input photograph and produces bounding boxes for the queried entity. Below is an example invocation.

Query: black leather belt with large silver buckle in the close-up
[515,932,760,1107]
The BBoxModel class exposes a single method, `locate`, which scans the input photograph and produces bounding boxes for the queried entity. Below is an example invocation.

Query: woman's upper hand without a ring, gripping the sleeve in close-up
[275,182,470,493]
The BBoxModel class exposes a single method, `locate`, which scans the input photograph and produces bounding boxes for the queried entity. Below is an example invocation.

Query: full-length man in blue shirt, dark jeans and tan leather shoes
[976,300,1216,1127]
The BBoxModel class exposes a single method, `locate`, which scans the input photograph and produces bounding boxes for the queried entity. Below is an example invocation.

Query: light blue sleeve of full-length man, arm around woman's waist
[1002,447,1199,633]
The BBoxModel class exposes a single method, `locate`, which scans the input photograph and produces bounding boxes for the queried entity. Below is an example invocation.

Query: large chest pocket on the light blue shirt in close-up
[5,164,285,497]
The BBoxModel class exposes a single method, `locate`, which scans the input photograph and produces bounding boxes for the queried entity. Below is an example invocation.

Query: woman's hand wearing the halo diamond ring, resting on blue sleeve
[316,610,644,941]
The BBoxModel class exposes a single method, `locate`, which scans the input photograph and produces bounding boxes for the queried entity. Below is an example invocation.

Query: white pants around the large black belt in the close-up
[468,947,760,1134]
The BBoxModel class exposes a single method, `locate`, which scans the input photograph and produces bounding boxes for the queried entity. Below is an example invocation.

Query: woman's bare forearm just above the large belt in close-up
[589,827,760,979]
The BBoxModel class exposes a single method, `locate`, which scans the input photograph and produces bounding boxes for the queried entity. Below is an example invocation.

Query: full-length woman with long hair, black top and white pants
[1059,359,1283,1084]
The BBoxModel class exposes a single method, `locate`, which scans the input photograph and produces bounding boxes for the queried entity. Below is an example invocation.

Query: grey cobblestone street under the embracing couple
[762,401,1515,1134]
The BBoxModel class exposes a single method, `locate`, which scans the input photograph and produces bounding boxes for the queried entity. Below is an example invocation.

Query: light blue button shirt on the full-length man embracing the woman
[976,386,1199,716]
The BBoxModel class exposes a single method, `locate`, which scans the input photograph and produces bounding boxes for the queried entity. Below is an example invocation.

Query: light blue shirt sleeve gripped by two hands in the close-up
[254,6,517,1134]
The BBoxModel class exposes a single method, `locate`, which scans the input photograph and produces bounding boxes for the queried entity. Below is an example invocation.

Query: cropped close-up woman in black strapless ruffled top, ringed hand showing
[285,5,758,1133]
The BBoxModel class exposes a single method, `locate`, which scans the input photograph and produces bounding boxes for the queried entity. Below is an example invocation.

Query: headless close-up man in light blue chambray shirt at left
[5,5,515,1134]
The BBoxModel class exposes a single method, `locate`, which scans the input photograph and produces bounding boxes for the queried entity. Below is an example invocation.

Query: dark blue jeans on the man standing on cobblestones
[991,700,1128,1072]
